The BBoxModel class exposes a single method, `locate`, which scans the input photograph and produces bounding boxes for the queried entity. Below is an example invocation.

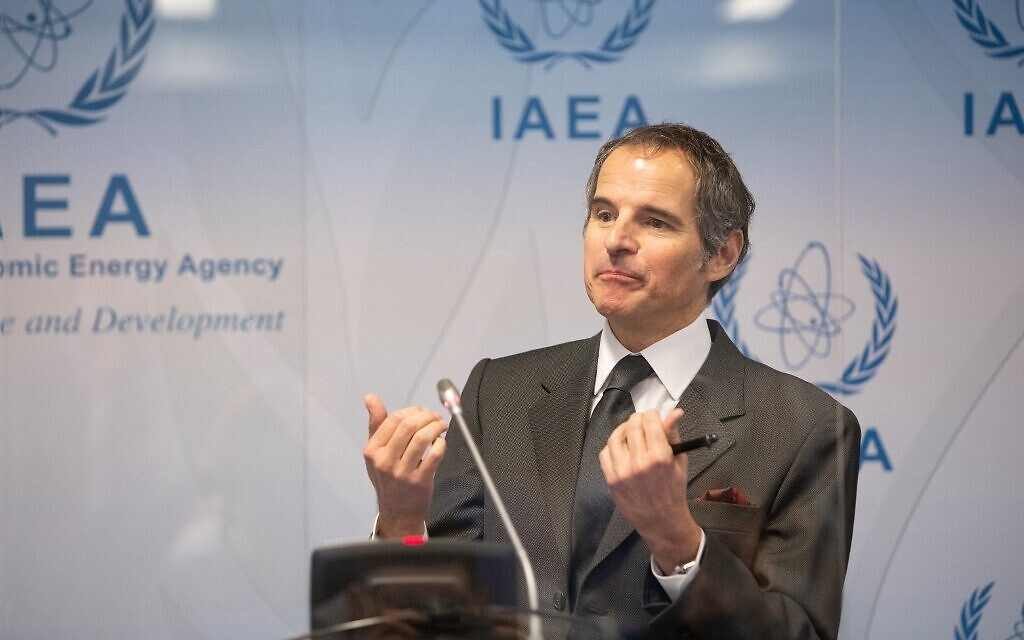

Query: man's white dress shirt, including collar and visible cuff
[590,313,711,601]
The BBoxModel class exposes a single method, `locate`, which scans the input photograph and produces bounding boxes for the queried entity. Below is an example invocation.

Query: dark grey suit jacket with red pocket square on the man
[428,322,860,640]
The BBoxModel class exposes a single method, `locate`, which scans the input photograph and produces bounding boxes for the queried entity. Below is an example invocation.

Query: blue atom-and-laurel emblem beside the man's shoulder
[712,242,899,395]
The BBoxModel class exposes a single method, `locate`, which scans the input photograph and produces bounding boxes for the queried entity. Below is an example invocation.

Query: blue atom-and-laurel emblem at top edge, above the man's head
[479,0,654,70]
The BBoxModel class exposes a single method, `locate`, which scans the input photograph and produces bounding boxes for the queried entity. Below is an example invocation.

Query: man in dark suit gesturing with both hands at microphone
[365,124,860,640]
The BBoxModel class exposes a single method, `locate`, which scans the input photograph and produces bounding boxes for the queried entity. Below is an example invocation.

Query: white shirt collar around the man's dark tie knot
[594,312,711,400]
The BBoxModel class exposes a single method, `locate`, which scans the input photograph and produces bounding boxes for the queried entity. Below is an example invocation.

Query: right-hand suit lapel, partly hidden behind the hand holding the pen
[581,321,745,580]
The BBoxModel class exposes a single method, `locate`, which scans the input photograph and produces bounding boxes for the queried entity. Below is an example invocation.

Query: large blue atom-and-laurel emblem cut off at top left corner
[0,0,156,135]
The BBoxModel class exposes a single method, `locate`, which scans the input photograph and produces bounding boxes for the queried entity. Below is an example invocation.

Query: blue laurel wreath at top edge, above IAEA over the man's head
[479,0,654,70]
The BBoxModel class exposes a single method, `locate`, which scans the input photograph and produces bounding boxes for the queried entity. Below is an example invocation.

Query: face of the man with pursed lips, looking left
[584,146,711,348]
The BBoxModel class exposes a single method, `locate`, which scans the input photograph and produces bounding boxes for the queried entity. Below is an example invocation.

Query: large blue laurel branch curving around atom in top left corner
[0,0,156,135]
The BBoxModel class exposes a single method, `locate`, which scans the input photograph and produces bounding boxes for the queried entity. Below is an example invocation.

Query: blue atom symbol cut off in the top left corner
[0,0,92,91]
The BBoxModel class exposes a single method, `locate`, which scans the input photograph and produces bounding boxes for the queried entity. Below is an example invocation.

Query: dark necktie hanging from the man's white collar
[570,355,653,596]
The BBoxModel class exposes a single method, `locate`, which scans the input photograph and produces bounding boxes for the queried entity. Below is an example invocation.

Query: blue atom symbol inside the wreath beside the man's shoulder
[754,242,856,370]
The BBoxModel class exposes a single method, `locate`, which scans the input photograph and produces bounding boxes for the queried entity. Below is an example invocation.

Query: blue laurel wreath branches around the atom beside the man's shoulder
[712,253,899,395]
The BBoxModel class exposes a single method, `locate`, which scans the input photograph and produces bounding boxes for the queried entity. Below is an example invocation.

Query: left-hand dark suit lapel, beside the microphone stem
[529,334,600,568]
